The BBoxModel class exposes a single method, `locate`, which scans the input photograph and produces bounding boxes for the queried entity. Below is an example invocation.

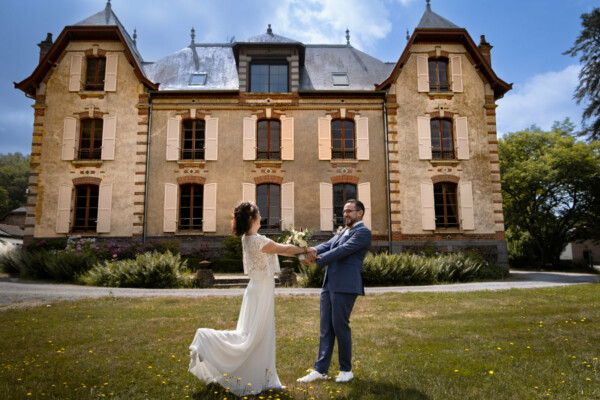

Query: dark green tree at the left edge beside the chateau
[0,153,29,215]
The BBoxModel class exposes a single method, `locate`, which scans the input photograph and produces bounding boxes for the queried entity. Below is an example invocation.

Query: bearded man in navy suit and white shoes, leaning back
[298,200,371,382]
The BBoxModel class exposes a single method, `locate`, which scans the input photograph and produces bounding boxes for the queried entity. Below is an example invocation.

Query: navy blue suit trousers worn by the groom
[314,282,358,374]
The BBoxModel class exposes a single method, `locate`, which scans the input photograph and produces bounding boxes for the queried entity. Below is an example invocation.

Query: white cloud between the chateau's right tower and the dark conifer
[496,65,581,135]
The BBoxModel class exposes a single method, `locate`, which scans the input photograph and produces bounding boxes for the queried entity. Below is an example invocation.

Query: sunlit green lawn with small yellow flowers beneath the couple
[0,284,600,400]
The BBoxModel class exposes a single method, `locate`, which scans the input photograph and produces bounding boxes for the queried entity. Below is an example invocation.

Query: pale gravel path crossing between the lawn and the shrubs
[0,271,600,310]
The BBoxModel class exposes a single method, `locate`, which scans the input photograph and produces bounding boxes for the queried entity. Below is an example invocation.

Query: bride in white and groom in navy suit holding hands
[189,200,371,396]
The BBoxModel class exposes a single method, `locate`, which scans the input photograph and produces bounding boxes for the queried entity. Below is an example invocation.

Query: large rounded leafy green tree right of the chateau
[498,118,600,266]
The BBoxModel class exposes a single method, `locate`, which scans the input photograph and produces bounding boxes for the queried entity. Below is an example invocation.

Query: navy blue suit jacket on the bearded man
[316,223,371,296]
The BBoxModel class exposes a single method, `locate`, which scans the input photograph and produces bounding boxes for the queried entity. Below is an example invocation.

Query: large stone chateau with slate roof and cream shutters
[15,1,511,265]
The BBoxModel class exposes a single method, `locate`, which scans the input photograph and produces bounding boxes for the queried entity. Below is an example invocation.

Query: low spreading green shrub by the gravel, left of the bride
[80,251,191,288]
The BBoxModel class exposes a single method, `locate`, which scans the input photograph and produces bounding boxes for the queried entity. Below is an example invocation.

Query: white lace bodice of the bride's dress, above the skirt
[242,234,280,279]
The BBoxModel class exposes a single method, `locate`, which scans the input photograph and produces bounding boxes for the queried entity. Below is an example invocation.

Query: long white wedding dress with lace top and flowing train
[189,234,281,396]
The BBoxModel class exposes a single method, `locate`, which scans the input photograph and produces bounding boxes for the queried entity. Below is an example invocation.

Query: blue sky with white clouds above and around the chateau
[0,0,600,154]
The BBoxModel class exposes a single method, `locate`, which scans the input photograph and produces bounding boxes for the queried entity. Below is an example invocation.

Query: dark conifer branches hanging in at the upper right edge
[564,8,600,140]
